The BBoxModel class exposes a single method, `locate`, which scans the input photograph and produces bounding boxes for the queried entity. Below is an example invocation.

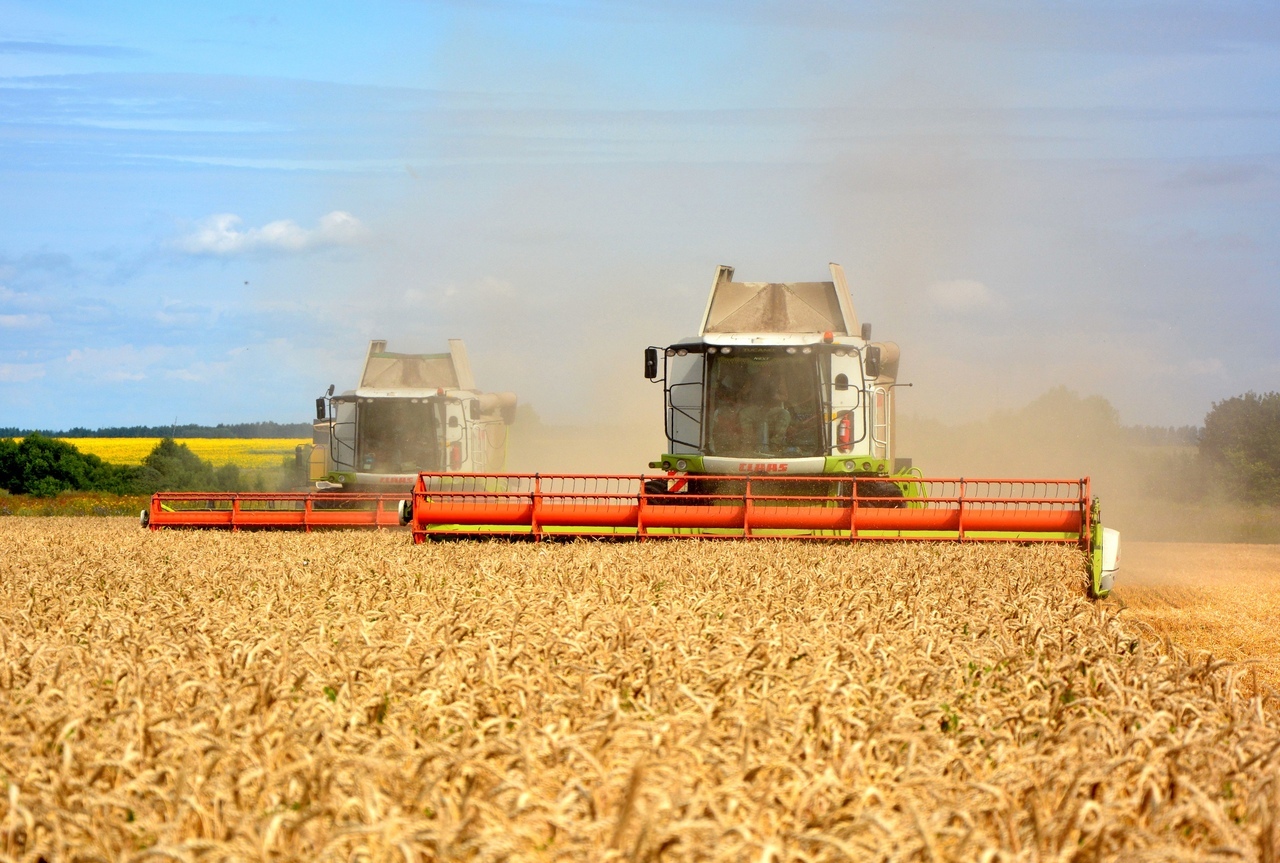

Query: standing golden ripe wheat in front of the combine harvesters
[0,519,1280,863]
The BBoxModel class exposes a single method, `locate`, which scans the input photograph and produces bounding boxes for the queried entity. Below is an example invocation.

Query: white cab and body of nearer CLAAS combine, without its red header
[645,264,911,486]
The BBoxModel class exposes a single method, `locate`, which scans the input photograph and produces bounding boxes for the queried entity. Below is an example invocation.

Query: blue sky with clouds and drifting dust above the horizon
[0,0,1280,430]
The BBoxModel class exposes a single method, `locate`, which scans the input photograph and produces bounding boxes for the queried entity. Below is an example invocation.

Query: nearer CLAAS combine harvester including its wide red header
[401,264,1120,597]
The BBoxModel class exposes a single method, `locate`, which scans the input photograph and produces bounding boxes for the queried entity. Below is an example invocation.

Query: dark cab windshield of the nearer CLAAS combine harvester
[704,348,826,458]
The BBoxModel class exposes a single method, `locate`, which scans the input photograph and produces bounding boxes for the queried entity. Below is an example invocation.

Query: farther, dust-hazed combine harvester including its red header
[142,339,516,530]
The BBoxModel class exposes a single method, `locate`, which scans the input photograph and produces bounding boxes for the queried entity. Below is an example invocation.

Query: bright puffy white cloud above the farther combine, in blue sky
[175,210,369,255]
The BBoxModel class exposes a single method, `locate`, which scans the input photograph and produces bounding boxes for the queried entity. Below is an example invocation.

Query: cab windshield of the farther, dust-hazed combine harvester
[356,398,443,474]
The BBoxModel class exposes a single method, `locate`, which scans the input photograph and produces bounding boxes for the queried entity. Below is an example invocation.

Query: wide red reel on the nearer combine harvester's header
[410,474,1091,543]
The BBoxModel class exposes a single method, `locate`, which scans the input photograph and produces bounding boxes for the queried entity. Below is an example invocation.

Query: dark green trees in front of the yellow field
[0,433,242,497]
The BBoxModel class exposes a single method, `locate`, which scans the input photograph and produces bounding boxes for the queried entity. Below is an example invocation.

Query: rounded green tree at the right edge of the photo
[1199,392,1280,503]
